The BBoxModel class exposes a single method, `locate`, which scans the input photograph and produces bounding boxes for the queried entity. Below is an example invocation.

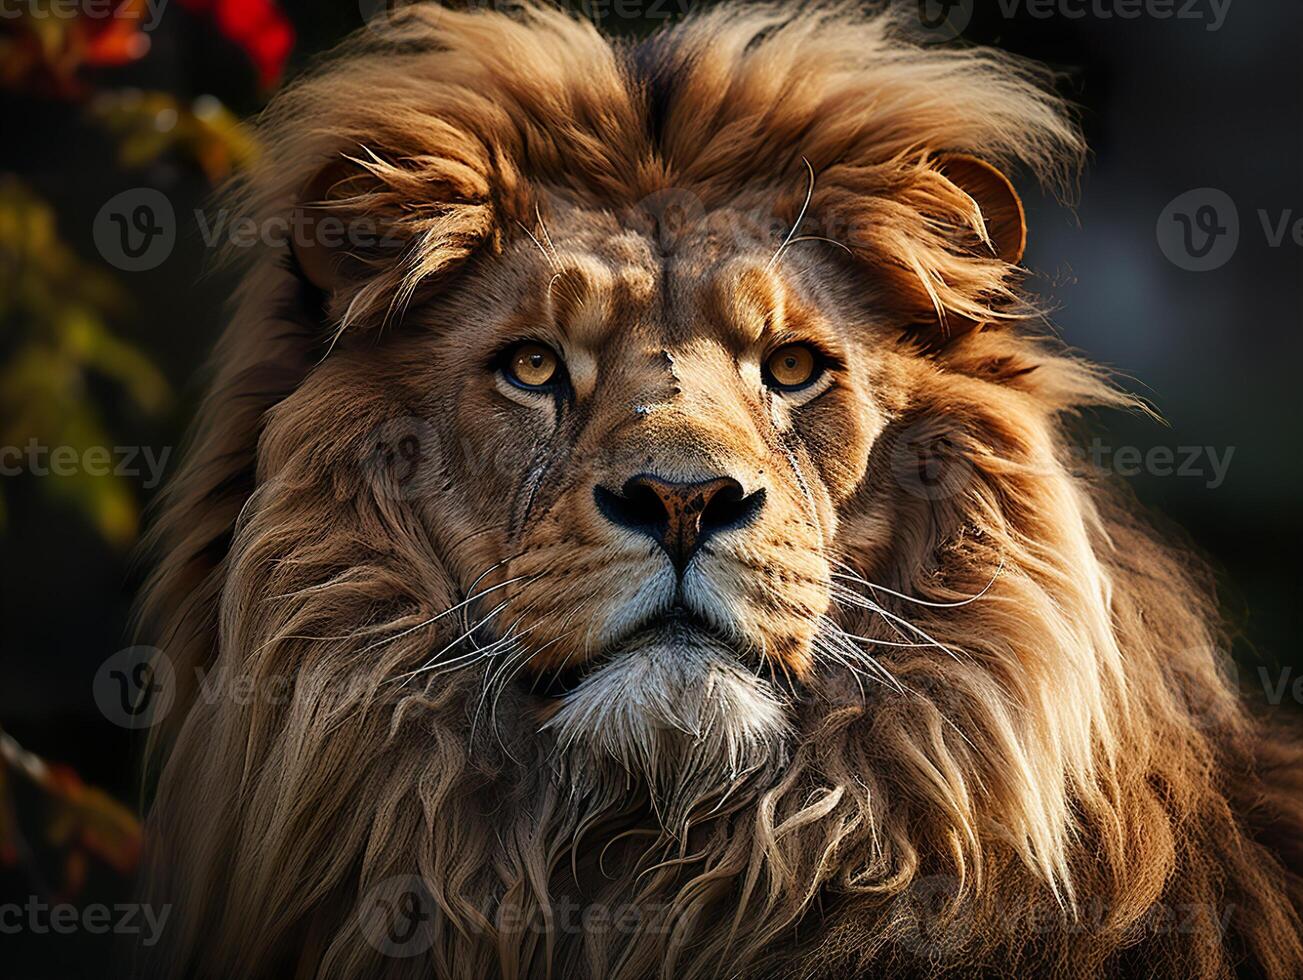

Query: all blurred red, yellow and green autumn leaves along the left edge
[0,0,286,943]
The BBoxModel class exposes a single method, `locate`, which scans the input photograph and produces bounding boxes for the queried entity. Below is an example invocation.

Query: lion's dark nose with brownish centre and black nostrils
[593,473,765,572]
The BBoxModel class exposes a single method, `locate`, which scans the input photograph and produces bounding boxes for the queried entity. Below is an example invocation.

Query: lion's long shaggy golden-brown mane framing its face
[141,4,1303,980]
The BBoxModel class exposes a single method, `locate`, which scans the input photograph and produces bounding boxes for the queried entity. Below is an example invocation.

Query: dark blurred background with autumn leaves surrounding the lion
[0,0,1303,977]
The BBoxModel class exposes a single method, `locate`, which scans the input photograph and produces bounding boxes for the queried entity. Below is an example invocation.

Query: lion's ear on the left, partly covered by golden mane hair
[291,147,495,322]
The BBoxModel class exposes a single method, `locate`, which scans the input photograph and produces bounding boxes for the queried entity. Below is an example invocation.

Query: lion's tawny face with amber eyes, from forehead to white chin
[377,196,881,770]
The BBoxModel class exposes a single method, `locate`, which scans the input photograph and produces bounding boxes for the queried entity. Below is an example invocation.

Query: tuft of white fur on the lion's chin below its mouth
[545,629,788,811]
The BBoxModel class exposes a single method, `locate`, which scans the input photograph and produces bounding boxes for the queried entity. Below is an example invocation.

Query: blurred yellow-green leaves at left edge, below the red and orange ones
[0,177,168,545]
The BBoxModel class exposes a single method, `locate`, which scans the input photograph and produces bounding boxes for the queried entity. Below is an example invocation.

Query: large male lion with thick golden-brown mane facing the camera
[141,4,1303,980]
